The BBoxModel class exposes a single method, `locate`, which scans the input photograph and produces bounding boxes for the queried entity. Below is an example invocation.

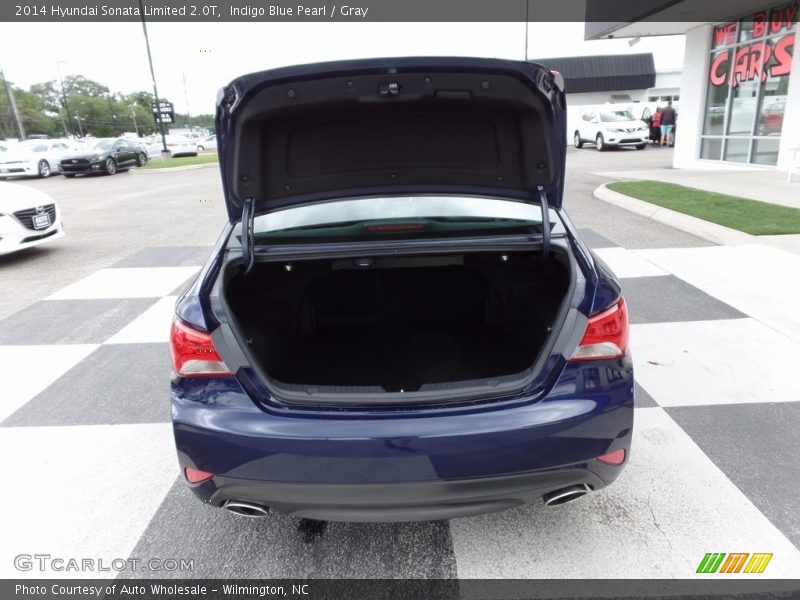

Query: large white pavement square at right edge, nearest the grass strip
[632,245,800,341]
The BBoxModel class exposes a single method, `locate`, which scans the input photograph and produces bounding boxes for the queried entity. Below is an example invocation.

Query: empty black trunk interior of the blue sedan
[224,252,570,393]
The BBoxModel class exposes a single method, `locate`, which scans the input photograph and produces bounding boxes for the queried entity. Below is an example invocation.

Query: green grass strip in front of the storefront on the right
[606,181,800,235]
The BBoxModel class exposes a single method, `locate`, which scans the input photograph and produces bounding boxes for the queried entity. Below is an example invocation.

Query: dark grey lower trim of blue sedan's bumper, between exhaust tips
[208,465,621,522]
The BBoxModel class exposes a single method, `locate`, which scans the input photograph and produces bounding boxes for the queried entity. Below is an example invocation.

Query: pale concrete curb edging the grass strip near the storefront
[592,184,758,246]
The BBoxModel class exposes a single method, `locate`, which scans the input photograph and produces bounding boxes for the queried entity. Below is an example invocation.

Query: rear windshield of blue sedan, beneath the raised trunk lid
[254,196,557,244]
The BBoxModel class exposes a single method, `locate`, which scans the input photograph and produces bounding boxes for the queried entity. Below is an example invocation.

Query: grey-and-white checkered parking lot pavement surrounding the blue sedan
[0,148,800,578]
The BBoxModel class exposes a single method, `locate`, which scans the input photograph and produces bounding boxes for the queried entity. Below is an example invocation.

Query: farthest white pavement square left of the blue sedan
[46,267,198,300]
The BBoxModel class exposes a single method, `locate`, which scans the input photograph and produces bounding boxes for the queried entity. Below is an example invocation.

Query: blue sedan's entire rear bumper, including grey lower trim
[172,358,633,521]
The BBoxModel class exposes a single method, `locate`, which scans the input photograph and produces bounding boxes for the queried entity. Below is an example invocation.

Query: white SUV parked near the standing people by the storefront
[574,108,650,151]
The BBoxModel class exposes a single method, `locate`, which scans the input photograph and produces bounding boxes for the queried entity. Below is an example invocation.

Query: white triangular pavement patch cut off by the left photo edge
[0,344,98,421]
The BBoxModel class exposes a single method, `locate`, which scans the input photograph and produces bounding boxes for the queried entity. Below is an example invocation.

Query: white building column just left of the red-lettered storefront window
[672,24,716,169]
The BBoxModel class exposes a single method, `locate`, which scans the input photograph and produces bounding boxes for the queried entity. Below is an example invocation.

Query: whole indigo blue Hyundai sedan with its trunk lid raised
[171,58,633,521]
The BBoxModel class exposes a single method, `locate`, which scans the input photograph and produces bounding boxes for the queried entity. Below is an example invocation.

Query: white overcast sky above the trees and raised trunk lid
[0,22,684,114]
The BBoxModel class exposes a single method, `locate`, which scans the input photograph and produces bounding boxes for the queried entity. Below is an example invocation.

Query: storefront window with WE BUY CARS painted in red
[700,3,800,165]
